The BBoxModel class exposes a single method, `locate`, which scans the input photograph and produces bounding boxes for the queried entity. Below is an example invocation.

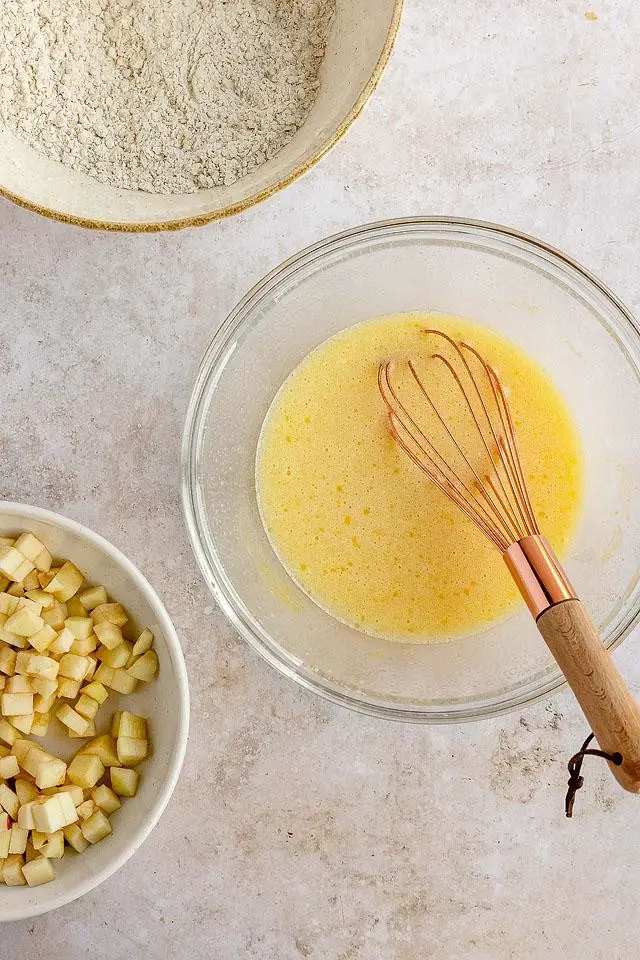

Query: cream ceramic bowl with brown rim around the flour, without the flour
[0,0,403,231]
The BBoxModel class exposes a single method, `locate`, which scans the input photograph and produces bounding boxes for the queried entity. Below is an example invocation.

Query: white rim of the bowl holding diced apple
[0,500,189,923]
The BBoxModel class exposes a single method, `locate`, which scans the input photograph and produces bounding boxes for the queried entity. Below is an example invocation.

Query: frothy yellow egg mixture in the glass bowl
[256,314,583,642]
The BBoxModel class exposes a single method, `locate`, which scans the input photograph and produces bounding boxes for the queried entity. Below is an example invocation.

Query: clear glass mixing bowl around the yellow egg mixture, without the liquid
[183,218,640,722]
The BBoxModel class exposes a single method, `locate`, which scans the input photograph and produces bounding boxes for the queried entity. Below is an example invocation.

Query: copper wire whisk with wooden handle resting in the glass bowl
[378,330,640,793]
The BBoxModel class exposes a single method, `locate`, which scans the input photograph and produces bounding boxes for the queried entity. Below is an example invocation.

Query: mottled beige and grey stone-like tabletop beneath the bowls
[0,0,640,960]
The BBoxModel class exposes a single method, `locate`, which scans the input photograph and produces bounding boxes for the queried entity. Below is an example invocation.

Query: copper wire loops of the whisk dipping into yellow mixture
[378,329,540,553]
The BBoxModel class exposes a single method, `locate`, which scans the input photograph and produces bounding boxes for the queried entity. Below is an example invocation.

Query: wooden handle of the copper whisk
[537,600,640,793]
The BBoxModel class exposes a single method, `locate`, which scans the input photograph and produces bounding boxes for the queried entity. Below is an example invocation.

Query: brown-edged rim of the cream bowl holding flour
[0,0,404,233]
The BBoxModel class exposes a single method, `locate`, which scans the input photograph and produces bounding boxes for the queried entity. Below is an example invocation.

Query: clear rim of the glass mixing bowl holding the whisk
[181,216,640,724]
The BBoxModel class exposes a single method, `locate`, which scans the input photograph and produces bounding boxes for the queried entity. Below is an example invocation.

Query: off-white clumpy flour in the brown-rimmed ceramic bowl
[0,0,335,193]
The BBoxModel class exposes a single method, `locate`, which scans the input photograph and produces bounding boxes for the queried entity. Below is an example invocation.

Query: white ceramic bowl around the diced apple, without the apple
[0,501,189,920]
